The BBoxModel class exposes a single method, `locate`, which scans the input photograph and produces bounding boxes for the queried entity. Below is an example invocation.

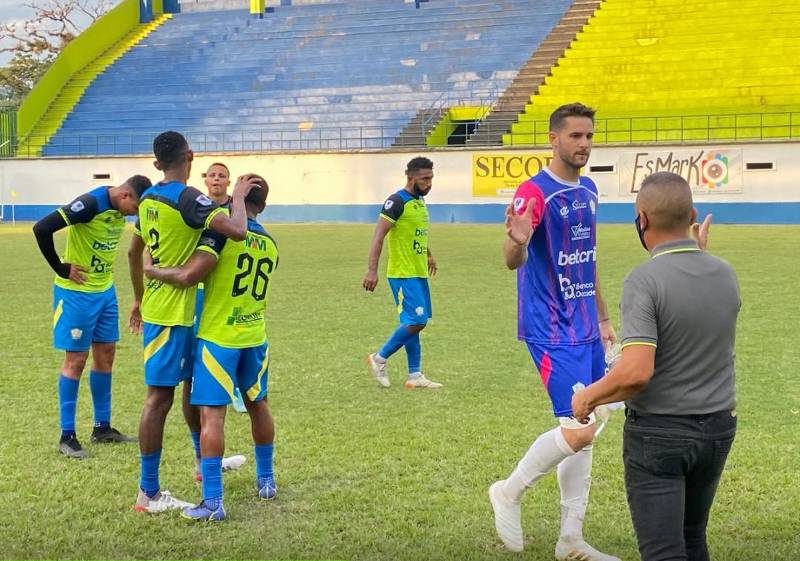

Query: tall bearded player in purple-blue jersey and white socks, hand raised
[489,103,619,561]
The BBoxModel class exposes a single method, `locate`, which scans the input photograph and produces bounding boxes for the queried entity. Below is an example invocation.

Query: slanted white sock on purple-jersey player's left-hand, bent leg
[502,427,575,502]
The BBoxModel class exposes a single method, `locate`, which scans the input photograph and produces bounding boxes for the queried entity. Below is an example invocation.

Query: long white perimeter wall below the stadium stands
[0,143,800,205]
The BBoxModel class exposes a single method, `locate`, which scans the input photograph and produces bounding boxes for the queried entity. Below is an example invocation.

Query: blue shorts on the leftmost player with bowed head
[53,285,119,352]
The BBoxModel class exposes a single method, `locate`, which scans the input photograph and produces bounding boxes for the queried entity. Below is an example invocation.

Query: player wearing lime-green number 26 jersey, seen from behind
[145,175,278,521]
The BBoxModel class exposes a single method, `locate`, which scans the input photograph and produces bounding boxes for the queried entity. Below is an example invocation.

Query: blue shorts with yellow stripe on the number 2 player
[144,322,194,387]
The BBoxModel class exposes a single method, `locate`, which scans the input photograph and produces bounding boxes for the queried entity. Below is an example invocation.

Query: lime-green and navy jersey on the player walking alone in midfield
[380,189,430,279]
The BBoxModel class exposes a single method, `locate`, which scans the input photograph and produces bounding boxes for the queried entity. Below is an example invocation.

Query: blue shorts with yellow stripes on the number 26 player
[191,339,269,405]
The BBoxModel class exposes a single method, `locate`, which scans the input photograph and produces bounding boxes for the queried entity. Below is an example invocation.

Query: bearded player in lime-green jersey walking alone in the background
[362,157,442,389]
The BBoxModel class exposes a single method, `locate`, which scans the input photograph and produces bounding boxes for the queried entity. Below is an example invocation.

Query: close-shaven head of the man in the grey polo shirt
[636,171,695,232]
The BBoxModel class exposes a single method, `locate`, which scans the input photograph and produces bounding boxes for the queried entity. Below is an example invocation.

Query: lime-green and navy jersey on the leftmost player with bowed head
[55,187,125,292]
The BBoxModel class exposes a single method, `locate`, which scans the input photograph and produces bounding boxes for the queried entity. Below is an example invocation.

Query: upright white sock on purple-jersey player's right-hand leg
[558,444,592,542]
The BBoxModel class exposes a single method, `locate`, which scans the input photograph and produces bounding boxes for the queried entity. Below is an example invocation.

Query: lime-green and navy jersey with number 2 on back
[136,181,223,326]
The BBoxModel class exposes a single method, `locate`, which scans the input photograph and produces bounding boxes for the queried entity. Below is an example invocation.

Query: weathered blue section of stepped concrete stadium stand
[37,0,571,156]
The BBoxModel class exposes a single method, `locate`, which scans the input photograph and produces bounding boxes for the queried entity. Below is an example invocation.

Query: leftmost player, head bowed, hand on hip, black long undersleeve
[33,175,150,459]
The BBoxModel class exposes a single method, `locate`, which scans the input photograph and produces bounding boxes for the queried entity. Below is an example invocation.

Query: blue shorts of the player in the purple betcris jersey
[528,339,608,417]
